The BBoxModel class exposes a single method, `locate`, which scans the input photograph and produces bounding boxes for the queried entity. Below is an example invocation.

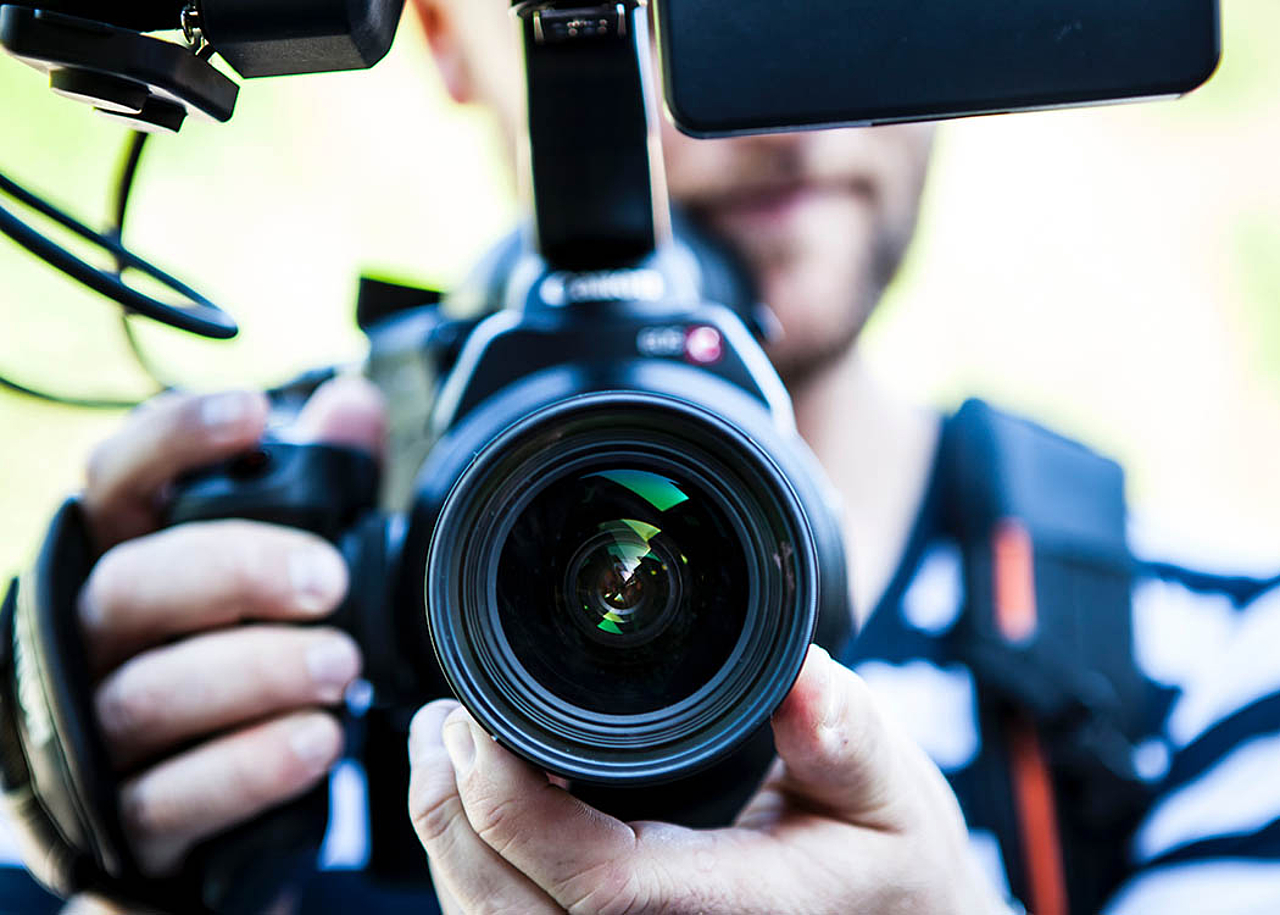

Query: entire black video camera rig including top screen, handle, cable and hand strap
[0,0,1219,911]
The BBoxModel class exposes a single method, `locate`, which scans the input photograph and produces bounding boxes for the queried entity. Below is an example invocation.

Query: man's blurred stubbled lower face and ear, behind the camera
[417,0,932,383]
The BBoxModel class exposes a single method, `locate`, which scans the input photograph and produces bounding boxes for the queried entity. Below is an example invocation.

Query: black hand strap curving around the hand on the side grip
[0,499,328,914]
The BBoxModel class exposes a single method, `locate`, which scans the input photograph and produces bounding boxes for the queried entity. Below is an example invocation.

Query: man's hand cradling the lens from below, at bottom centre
[410,649,1007,915]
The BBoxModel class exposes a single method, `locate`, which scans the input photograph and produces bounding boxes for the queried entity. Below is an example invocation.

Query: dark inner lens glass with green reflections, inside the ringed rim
[494,462,753,714]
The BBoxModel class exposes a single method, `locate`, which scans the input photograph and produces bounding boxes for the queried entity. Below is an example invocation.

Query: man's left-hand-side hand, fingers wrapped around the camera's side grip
[79,381,383,875]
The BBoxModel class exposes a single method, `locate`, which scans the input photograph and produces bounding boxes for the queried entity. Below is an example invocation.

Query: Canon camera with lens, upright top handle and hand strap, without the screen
[0,0,851,911]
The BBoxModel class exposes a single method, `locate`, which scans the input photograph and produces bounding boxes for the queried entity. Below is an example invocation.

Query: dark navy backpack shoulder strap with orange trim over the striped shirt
[940,401,1156,915]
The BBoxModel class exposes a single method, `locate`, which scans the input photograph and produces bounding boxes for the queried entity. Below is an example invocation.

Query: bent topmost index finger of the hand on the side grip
[83,392,270,550]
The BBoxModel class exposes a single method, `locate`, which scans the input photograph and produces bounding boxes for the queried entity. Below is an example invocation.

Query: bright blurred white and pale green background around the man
[0,0,1280,572]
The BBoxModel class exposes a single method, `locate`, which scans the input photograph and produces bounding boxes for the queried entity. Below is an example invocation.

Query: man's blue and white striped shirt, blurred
[844,442,1280,915]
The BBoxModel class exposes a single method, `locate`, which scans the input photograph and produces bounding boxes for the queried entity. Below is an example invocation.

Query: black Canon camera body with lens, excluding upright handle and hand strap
[170,224,851,844]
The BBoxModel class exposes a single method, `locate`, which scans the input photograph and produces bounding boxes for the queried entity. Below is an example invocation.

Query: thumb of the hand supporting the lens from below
[773,645,914,829]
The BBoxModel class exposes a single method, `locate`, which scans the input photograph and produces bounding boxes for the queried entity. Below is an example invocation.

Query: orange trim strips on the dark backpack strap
[992,520,1069,915]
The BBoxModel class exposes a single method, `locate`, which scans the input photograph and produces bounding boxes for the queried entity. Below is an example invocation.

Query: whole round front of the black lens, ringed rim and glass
[425,393,819,786]
